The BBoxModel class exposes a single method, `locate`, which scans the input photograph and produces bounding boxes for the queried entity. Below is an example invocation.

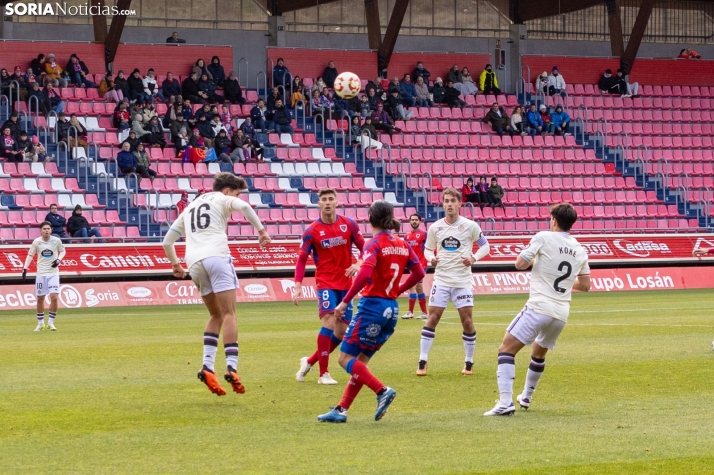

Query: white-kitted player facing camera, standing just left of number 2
[416,188,490,376]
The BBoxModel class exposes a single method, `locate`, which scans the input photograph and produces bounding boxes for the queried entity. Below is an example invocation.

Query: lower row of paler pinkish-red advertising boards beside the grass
[0,267,714,316]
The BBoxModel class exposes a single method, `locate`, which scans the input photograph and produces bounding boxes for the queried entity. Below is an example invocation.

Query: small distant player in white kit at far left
[22,221,65,332]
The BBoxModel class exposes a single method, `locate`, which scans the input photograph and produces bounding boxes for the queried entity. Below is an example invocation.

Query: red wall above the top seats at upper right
[521,55,714,86]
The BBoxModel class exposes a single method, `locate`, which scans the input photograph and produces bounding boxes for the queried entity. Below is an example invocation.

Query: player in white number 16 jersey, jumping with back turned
[164,173,270,396]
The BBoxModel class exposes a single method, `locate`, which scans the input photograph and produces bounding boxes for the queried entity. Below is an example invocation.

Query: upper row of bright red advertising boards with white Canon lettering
[0,234,714,279]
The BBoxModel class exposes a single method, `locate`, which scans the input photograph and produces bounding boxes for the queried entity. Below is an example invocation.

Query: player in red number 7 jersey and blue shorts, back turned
[317,200,424,422]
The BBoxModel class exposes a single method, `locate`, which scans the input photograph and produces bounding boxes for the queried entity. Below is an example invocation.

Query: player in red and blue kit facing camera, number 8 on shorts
[293,188,364,384]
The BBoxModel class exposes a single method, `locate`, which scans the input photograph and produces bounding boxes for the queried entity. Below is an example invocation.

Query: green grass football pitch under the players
[0,291,714,475]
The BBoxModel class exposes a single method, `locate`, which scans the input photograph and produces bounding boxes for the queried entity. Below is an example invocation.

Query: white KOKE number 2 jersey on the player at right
[521,231,590,322]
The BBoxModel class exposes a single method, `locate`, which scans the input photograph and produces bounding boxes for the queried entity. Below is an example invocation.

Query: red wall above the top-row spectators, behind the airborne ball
[267,48,491,81]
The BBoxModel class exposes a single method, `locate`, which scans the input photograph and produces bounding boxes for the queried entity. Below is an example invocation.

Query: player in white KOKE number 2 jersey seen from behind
[484,203,590,416]
